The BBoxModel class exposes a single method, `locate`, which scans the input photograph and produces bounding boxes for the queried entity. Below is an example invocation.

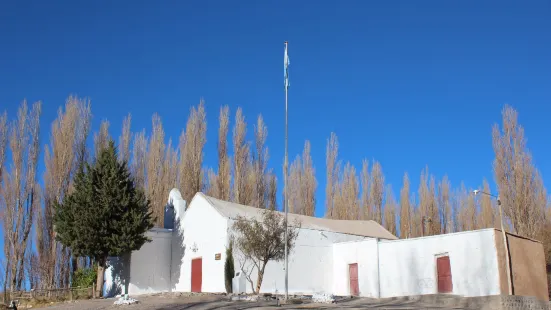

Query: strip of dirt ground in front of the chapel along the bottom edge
[34,294,474,310]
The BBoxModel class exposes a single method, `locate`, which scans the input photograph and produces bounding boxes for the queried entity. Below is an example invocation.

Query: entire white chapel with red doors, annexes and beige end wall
[104,189,548,300]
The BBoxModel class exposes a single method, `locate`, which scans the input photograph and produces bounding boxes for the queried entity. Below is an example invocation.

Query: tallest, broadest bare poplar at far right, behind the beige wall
[492,106,545,237]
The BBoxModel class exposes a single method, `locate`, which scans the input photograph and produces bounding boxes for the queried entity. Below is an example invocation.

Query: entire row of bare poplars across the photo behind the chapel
[0,96,551,290]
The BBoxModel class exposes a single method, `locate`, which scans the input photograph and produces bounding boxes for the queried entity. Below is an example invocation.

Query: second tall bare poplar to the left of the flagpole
[233,108,254,205]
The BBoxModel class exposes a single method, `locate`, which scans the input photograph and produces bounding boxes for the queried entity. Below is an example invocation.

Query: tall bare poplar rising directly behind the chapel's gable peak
[179,99,207,202]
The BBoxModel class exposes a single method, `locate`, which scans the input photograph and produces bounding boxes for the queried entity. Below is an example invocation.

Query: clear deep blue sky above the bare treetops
[0,0,551,225]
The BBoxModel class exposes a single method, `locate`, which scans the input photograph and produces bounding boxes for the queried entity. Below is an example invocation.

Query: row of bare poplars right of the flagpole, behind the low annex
[325,106,551,245]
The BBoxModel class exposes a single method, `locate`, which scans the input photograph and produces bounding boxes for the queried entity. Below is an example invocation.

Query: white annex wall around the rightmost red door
[380,229,500,297]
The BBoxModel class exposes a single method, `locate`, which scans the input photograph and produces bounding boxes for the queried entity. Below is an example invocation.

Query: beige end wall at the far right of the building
[495,229,549,301]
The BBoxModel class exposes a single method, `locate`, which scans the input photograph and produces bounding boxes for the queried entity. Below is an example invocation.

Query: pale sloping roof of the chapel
[196,192,398,240]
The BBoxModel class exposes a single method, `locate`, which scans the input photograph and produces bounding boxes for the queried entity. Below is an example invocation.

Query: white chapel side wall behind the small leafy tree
[230,224,365,294]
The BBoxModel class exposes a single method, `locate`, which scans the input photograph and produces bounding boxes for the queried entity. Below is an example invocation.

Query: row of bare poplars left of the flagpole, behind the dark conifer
[0,96,284,291]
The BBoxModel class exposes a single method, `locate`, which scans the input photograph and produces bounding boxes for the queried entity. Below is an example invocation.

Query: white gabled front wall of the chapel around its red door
[172,195,228,292]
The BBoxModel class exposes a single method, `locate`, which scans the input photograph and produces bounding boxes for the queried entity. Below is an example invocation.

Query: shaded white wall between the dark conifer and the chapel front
[128,229,172,295]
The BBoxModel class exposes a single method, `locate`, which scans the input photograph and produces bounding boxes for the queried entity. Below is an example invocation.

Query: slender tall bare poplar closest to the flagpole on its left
[253,115,269,208]
